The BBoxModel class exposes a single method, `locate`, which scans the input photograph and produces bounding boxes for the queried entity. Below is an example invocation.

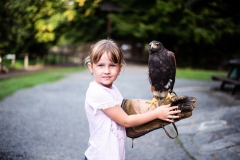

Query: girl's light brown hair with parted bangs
[84,39,125,65]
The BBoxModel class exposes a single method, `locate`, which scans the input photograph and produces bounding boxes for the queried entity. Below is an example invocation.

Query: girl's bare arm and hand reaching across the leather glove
[103,105,181,127]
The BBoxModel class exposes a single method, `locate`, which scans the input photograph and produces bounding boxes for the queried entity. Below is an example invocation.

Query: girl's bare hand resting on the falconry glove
[155,104,181,122]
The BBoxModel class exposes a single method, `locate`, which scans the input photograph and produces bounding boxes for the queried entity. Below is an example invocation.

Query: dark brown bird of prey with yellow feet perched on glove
[148,40,176,107]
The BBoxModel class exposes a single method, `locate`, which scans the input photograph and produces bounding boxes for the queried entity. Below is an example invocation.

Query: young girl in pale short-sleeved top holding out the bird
[85,39,180,160]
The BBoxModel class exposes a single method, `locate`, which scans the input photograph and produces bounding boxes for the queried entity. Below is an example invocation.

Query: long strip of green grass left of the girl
[0,67,85,101]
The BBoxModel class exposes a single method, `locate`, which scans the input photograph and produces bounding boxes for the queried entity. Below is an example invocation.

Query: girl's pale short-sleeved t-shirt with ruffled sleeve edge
[85,82,126,160]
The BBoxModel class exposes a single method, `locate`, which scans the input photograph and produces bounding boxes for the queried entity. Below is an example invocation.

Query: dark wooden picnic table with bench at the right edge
[212,59,240,95]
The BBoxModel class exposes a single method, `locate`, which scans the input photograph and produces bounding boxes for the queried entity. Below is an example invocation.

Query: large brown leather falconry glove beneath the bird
[121,95,196,138]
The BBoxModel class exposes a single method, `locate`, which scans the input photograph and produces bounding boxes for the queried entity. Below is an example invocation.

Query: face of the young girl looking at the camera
[88,53,122,88]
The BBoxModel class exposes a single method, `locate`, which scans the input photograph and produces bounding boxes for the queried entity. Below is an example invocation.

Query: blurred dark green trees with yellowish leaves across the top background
[0,0,240,69]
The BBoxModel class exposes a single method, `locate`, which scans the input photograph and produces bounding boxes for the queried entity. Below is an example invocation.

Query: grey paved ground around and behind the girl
[0,65,240,160]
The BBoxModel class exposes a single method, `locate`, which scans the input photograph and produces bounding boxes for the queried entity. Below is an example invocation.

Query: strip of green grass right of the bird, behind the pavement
[176,68,227,81]
